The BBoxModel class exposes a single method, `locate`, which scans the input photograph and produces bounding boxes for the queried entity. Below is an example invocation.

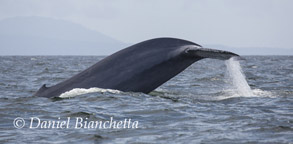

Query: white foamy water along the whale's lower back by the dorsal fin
[59,87,121,98]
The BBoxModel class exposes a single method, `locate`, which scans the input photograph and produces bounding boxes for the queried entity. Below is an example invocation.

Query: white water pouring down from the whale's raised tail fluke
[225,58,254,97]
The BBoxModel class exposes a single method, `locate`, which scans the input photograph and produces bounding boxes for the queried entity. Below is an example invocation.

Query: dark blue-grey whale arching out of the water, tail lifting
[35,38,238,98]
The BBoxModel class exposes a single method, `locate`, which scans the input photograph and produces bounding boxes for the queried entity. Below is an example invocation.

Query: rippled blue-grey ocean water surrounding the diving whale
[0,56,293,144]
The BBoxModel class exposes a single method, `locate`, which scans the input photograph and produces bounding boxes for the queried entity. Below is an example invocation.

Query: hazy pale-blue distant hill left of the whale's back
[0,17,127,55]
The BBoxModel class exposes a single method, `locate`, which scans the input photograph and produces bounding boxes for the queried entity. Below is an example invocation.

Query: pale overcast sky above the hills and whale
[0,0,293,49]
